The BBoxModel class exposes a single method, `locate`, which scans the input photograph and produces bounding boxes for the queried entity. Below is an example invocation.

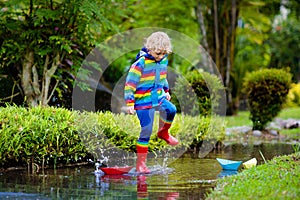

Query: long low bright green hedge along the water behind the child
[0,106,225,169]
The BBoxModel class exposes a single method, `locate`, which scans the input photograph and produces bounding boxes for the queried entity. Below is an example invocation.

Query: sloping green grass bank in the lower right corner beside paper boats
[206,152,300,199]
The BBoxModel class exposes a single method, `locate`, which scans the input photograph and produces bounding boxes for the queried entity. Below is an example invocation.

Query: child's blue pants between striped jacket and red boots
[136,99,176,142]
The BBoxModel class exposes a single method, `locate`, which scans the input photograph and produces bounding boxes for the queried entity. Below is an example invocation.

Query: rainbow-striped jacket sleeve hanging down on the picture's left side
[124,57,145,106]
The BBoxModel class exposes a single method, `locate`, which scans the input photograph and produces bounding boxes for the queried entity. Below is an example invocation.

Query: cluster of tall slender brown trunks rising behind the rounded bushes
[196,0,240,114]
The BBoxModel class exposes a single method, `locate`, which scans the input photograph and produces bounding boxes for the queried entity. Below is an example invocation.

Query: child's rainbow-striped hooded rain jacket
[124,48,169,110]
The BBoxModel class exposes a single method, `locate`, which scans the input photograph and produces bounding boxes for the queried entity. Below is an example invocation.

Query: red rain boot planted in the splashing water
[136,145,150,174]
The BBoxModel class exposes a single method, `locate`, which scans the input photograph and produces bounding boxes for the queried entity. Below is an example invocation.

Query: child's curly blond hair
[144,31,172,54]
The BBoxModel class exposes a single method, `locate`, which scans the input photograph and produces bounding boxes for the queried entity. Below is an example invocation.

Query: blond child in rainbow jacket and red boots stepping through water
[124,32,178,173]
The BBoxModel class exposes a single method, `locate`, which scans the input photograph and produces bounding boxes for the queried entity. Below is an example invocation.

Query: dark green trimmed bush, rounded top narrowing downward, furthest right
[243,69,292,130]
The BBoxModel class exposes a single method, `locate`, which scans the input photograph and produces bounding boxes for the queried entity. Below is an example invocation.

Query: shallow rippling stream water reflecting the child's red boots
[0,143,293,200]
